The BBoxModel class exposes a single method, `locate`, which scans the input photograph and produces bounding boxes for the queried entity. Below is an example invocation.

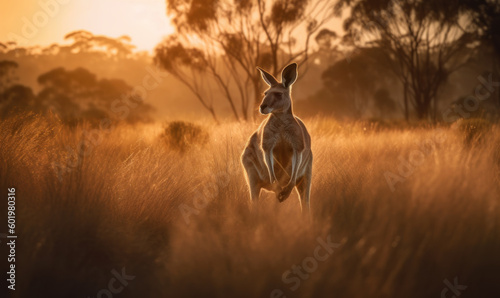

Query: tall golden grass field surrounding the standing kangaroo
[0,116,500,297]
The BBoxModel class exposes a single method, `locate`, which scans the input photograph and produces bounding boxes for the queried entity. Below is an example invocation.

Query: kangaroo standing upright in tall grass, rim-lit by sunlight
[241,63,313,211]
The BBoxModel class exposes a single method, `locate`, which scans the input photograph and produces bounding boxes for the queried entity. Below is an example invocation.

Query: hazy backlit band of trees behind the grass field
[0,0,500,124]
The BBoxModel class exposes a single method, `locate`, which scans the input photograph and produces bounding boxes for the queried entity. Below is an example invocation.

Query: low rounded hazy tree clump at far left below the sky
[0,67,153,126]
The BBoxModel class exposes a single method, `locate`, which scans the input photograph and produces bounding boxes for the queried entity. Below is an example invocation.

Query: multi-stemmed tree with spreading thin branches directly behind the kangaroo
[156,0,334,119]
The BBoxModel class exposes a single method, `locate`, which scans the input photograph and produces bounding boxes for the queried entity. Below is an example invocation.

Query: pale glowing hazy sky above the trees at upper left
[0,0,173,50]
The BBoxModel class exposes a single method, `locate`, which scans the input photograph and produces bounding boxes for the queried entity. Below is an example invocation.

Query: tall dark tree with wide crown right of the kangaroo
[337,0,475,120]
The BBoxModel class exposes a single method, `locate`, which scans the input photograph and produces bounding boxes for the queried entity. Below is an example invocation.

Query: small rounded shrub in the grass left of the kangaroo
[161,121,208,153]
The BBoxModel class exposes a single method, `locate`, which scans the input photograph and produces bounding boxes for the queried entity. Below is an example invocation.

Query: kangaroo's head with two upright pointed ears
[257,63,297,115]
